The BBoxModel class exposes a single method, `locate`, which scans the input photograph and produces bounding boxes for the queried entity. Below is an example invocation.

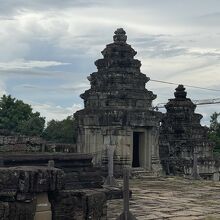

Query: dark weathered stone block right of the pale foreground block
[49,190,107,220]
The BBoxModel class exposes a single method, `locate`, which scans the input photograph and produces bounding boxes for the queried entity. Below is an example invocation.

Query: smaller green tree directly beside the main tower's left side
[43,116,77,143]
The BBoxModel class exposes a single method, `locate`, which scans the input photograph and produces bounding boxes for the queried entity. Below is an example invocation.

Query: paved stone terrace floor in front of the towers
[108,177,220,220]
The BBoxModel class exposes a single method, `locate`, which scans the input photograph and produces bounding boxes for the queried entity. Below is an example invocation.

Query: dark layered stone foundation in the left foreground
[0,154,122,220]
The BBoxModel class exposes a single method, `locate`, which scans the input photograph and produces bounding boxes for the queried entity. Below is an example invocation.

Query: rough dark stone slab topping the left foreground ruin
[0,166,64,193]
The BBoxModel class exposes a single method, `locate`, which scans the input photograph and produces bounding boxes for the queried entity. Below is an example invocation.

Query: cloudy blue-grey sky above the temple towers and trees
[0,0,220,124]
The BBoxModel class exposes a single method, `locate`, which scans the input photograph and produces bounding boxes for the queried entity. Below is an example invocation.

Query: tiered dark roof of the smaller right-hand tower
[162,85,210,139]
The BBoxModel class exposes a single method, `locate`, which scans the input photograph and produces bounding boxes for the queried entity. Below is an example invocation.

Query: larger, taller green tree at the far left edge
[0,95,45,136]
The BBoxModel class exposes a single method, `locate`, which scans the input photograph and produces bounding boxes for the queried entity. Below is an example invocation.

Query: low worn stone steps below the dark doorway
[130,167,159,181]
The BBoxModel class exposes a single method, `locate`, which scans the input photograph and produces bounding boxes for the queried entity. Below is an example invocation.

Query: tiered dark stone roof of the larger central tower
[81,28,156,110]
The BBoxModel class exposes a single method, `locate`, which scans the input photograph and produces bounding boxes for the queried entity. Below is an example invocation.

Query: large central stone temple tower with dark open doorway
[75,28,162,172]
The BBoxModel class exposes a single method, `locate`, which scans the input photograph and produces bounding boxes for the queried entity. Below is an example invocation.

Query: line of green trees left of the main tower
[0,95,76,143]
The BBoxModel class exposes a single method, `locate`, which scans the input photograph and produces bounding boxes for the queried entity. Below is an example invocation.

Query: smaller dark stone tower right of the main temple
[160,85,214,179]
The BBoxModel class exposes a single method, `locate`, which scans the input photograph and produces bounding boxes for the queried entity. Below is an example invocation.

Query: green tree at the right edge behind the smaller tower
[209,112,220,153]
